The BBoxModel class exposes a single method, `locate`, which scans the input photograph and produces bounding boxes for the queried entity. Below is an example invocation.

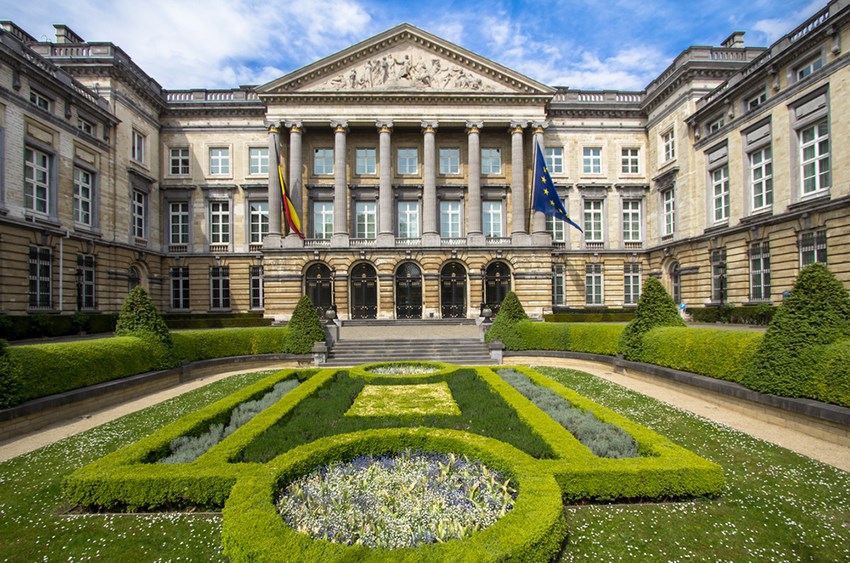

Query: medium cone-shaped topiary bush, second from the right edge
[617,278,685,362]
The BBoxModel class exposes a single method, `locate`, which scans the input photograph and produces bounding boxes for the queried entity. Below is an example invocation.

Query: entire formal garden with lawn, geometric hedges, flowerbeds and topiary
[0,266,850,561]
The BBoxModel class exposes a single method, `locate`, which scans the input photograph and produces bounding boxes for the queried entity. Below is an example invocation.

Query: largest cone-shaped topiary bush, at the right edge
[741,264,850,397]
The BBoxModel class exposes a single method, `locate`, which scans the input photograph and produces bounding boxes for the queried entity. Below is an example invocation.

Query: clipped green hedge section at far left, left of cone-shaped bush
[0,336,176,407]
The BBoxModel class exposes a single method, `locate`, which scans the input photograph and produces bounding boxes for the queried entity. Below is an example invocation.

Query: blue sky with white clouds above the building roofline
[0,0,827,90]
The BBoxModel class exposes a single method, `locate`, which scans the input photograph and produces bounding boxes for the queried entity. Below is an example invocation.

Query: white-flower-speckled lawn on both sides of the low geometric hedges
[0,368,850,562]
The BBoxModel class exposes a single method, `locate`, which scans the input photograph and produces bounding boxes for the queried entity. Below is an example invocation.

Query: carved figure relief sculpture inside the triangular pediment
[317,50,494,92]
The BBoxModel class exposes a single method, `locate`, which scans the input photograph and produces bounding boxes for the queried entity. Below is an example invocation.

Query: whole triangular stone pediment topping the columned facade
[257,24,554,96]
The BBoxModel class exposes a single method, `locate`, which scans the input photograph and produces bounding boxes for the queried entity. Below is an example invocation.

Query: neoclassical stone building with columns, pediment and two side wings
[0,0,850,320]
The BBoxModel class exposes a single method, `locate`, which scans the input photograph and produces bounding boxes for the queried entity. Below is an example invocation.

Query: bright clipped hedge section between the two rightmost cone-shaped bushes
[640,327,764,383]
